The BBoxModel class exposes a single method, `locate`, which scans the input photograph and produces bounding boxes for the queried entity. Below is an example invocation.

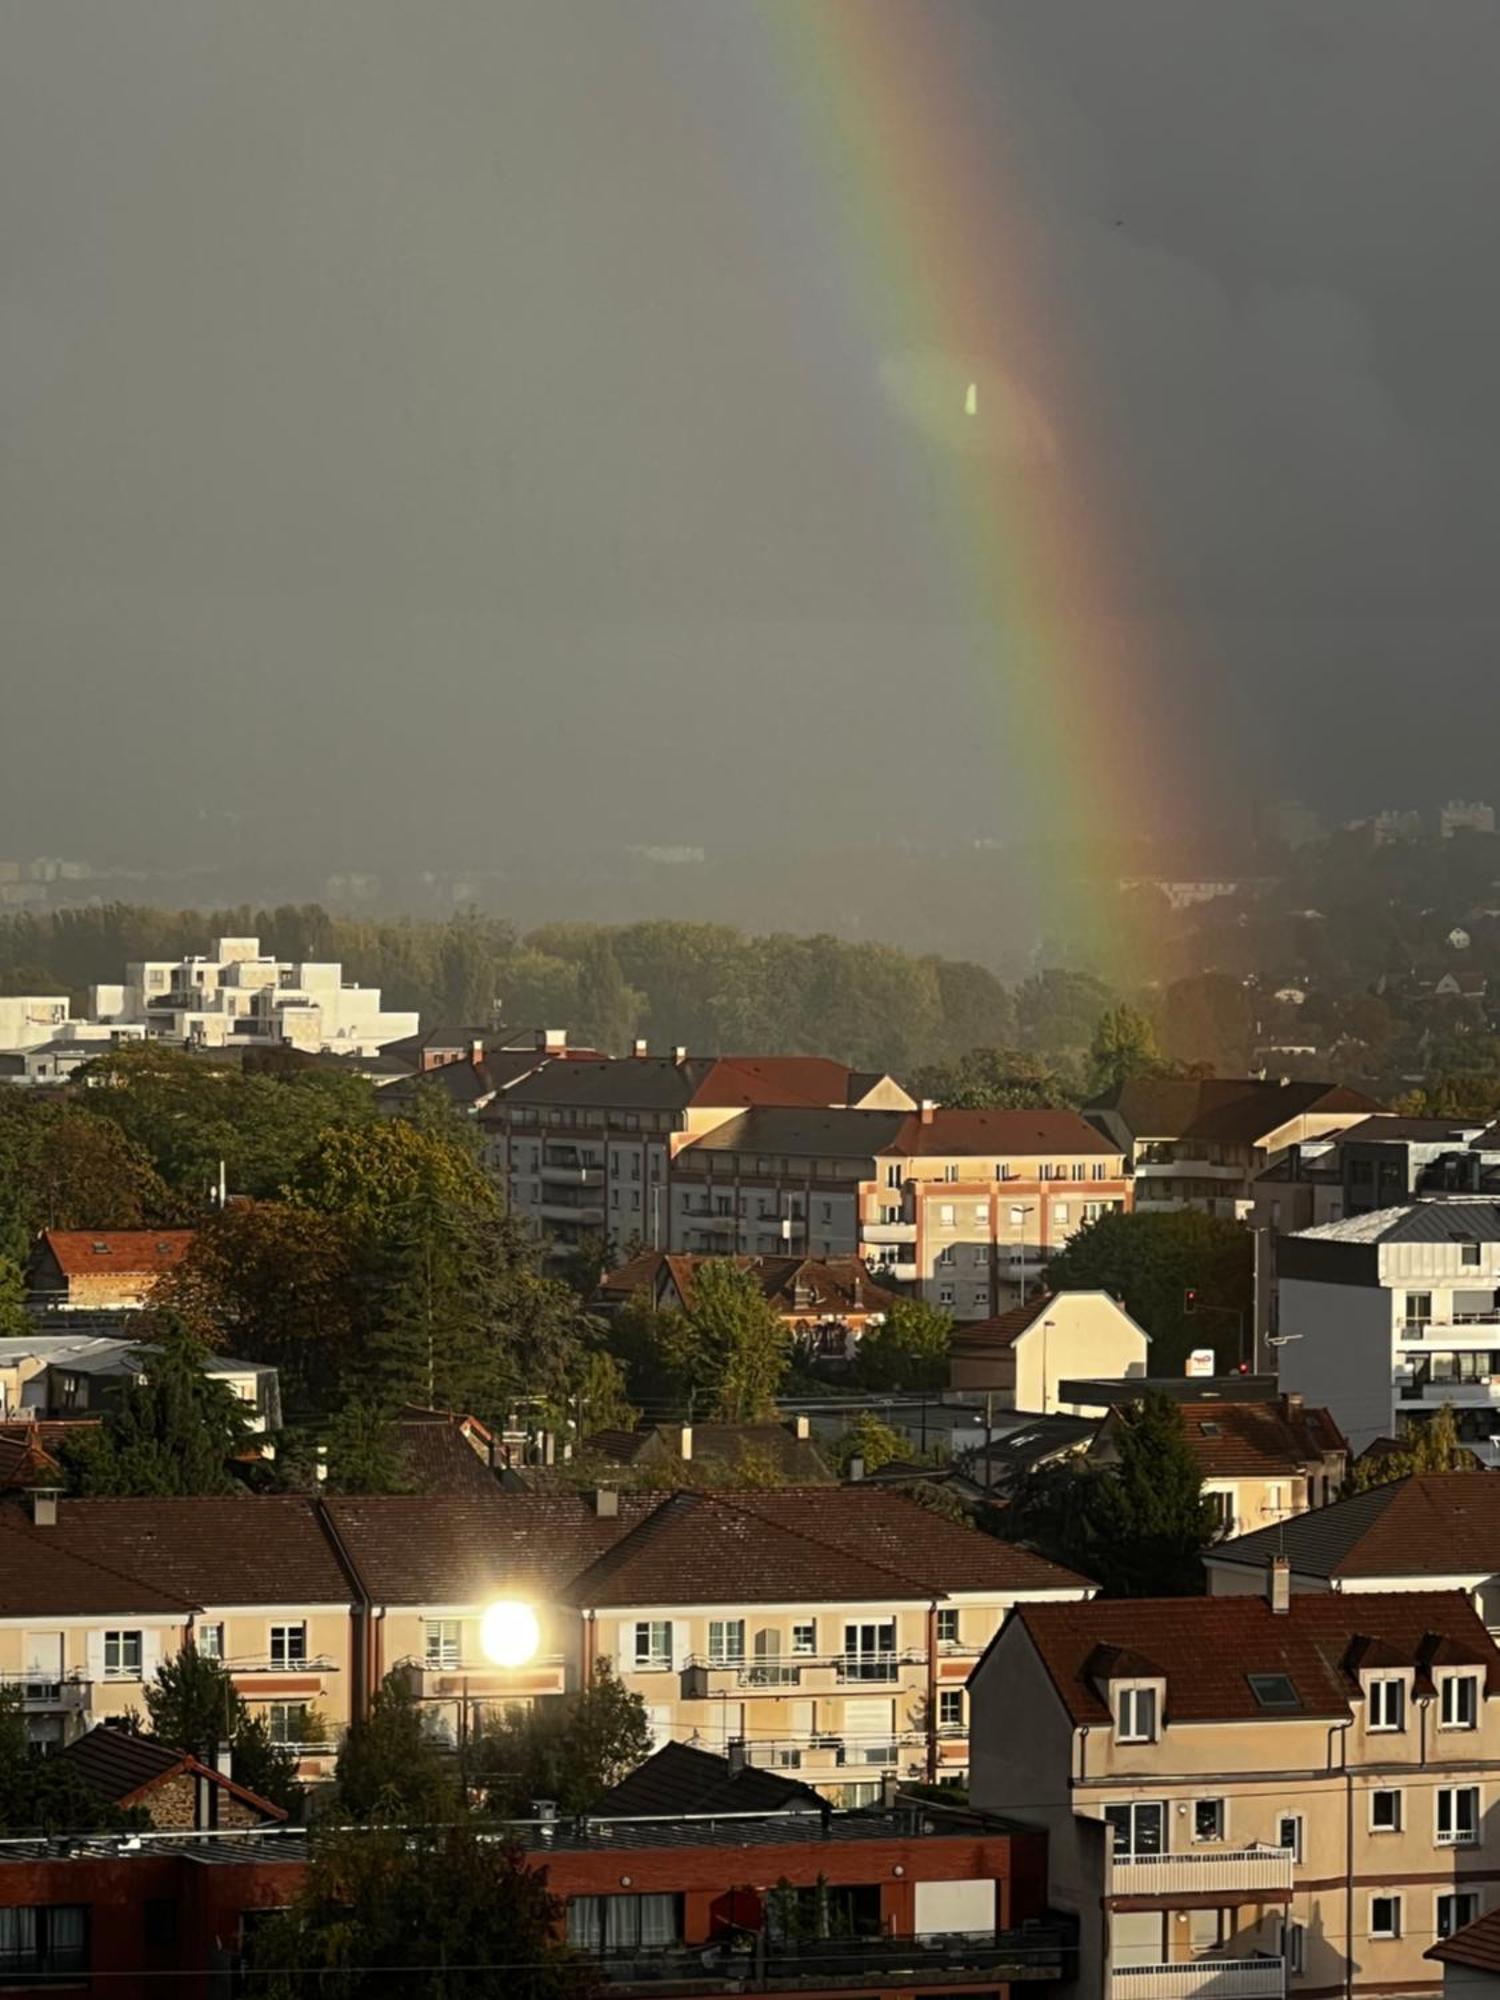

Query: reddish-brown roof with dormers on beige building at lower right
[1012,1590,1500,1726]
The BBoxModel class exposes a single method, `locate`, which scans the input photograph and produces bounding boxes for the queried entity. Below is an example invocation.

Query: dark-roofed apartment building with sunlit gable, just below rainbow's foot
[1084,1076,1380,1220]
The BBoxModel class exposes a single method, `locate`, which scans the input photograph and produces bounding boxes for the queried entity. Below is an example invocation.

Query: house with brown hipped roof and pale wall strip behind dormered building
[1204,1472,1500,1632]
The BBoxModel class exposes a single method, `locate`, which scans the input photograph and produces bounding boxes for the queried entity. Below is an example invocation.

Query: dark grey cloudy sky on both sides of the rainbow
[0,0,1500,872]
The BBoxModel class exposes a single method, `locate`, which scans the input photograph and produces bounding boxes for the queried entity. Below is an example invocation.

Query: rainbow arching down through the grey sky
[712,0,1190,966]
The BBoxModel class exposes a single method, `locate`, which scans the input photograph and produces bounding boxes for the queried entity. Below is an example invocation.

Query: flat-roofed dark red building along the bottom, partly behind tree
[0,1800,1076,2000]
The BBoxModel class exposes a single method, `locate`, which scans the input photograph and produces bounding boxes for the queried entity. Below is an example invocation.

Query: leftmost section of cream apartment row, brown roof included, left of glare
[0,1492,356,1778]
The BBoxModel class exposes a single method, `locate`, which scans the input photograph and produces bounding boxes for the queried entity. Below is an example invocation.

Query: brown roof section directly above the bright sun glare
[324,1488,660,1604]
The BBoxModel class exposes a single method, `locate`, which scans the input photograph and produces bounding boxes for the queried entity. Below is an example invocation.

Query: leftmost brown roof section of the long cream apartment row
[0,1494,354,1610]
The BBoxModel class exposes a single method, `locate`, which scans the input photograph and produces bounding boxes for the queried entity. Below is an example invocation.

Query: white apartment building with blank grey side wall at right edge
[1272,1196,1500,1466]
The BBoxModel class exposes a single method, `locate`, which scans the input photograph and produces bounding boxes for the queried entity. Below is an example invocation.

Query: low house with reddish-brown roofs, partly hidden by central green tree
[592,1250,898,1360]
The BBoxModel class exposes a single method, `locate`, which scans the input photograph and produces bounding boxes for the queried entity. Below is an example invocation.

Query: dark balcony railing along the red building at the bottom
[582,1924,1074,1994]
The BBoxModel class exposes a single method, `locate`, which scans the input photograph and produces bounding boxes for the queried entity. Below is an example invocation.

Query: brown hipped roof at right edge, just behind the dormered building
[1214,1472,1500,1576]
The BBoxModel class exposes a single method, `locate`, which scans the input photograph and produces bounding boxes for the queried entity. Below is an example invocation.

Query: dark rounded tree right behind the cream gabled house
[1046,1208,1254,1374]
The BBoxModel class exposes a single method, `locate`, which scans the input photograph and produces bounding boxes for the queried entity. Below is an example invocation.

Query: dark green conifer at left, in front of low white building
[64,1316,250,1496]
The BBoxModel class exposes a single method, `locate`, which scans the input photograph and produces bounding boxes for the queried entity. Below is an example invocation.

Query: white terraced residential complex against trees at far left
[0,938,420,1082]
